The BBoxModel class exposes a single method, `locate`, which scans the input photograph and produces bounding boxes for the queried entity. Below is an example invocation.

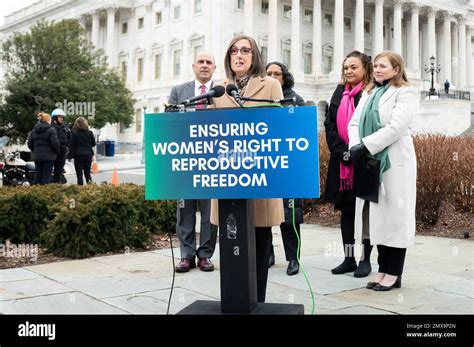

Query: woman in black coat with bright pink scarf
[324,51,373,277]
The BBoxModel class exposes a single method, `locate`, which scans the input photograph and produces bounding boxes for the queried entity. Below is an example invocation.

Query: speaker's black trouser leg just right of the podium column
[255,227,272,302]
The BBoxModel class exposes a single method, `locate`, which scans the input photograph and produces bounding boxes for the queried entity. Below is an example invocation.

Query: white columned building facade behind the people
[0,0,474,143]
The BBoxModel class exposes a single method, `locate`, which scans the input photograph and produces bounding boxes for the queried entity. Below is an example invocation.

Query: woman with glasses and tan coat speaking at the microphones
[210,35,285,302]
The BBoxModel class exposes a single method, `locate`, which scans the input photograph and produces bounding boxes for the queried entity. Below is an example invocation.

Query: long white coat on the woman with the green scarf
[349,86,419,248]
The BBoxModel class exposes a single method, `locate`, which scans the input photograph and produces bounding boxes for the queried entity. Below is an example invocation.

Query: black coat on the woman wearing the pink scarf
[324,84,362,211]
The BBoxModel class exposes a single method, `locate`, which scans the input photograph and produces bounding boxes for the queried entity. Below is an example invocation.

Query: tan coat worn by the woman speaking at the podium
[210,77,285,227]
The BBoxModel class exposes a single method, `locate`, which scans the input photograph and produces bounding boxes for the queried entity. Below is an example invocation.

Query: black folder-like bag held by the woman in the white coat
[352,157,380,203]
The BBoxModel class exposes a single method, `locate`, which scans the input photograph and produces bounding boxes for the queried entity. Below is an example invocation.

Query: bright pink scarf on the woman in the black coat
[337,82,363,190]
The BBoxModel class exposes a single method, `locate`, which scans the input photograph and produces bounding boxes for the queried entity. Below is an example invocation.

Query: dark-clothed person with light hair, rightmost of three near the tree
[68,117,95,186]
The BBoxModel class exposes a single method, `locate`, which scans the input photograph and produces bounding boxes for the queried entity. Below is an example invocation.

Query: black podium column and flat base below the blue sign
[178,199,304,315]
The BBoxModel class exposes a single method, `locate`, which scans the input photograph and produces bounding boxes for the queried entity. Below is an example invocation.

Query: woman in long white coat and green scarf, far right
[349,52,419,291]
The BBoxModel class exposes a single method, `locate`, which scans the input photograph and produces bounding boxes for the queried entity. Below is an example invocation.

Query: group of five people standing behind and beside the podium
[169,35,418,302]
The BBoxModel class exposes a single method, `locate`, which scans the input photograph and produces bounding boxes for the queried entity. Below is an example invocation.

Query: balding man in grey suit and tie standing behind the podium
[168,53,217,272]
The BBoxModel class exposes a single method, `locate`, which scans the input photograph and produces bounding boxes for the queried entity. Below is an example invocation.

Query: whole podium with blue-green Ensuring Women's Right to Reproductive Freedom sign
[145,107,319,315]
